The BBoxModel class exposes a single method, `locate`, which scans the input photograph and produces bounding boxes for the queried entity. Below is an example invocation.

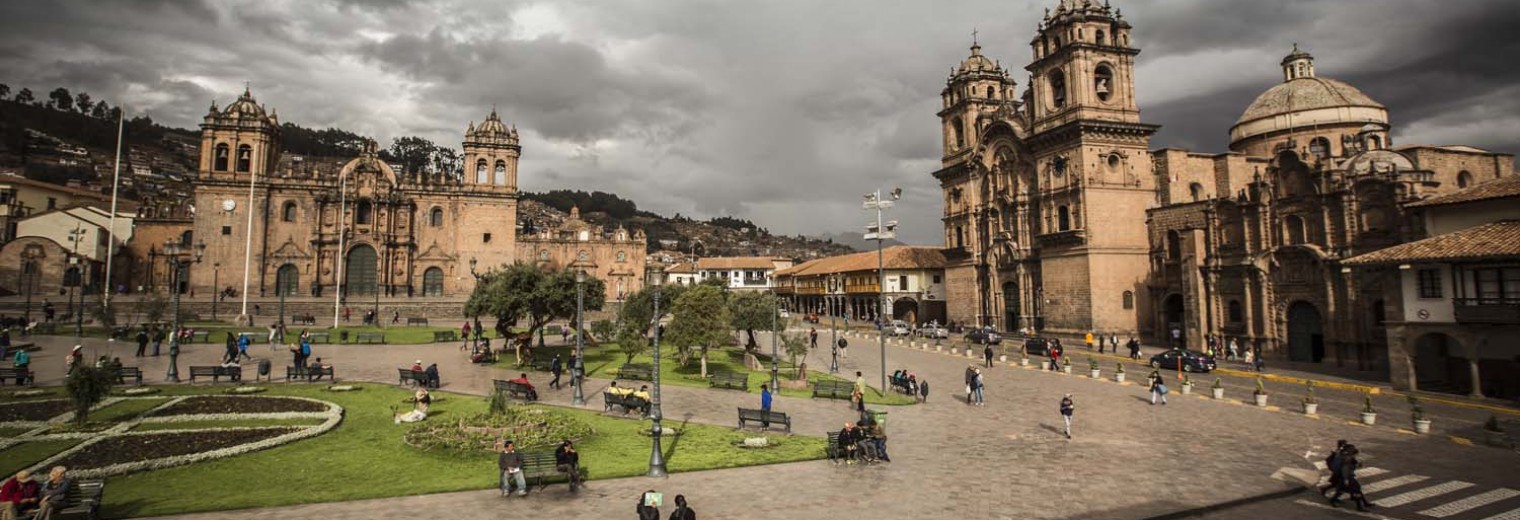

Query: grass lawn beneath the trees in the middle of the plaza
[497,344,917,404]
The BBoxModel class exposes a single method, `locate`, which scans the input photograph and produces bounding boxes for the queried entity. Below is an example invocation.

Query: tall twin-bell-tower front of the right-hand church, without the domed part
[933,0,1157,333]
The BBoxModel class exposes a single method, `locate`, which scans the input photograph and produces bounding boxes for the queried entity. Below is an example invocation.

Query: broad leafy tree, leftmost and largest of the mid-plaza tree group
[465,262,606,363]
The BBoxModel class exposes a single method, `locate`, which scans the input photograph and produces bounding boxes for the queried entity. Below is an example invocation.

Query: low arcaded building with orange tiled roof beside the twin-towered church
[775,246,945,324]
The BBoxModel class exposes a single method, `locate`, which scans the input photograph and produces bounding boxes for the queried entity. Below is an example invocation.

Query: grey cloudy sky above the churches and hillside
[0,0,1520,243]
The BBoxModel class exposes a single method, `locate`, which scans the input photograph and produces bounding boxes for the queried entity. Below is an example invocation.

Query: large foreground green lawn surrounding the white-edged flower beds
[86,385,825,517]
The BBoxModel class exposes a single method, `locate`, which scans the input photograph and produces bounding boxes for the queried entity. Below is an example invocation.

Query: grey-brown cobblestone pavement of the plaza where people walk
[11,331,1520,520]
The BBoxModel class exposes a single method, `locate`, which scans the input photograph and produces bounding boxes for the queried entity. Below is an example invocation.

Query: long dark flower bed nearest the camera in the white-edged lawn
[53,427,296,470]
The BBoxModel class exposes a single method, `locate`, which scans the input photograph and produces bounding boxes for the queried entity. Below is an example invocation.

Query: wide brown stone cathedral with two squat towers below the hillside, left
[164,91,644,301]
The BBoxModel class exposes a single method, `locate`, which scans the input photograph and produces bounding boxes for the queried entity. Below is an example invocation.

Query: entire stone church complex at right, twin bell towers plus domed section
[933,0,1514,369]
